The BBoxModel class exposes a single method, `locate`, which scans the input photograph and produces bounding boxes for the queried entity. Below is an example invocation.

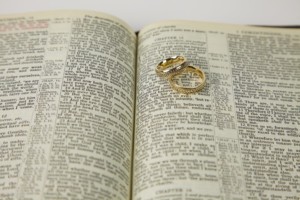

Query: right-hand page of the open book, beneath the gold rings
[133,21,300,200]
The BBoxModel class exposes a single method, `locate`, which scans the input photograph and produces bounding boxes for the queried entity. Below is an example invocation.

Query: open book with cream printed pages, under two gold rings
[0,11,300,200]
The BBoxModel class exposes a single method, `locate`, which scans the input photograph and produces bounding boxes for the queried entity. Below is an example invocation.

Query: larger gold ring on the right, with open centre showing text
[169,65,206,94]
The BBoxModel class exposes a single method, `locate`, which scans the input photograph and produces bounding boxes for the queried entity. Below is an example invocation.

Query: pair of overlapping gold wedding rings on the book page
[155,56,206,94]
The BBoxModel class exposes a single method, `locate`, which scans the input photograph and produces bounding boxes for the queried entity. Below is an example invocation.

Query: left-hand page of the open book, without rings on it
[0,11,136,200]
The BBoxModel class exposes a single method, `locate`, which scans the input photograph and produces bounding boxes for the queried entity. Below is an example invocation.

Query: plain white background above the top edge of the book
[0,0,300,30]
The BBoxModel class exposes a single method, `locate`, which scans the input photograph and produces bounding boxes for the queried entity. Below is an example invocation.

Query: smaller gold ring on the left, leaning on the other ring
[155,56,188,79]
